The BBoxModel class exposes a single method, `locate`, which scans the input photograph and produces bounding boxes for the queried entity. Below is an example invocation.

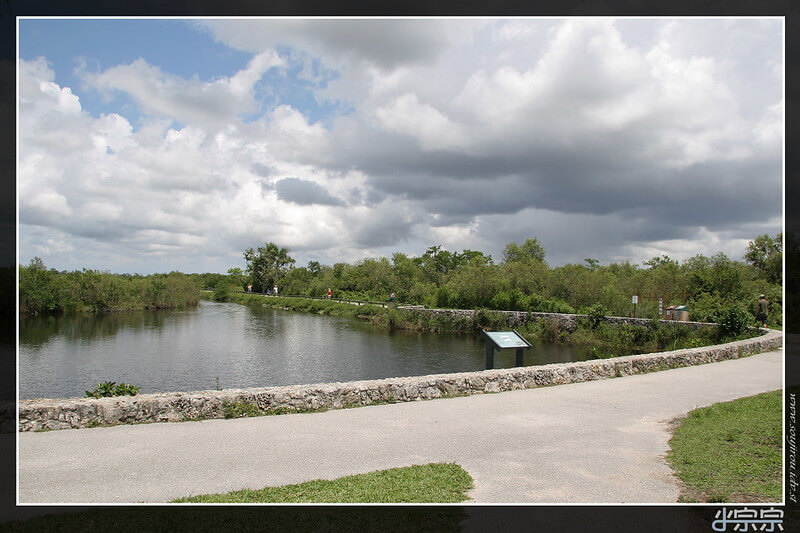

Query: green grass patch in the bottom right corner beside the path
[667,391,782,503]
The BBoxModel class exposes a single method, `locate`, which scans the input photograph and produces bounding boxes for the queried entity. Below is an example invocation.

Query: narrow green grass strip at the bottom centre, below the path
[167,463,472,503]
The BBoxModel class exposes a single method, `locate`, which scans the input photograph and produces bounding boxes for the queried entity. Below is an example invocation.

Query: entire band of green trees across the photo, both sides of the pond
[19,234,780,327]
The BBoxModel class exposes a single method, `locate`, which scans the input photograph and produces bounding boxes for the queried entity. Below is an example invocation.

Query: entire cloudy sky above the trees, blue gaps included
[17,17,784,274]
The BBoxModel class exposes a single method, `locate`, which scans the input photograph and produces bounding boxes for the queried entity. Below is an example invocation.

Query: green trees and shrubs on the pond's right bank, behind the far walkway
[223,233,783,327]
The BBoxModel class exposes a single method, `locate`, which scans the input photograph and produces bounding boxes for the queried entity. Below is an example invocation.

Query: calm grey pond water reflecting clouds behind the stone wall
[19,301,588,398]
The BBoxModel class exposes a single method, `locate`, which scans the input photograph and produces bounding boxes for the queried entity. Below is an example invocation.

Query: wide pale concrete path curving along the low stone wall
[19,350,783,503]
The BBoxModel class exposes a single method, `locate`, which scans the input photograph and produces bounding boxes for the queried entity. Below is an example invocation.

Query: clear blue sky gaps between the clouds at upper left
[19,19,352,126]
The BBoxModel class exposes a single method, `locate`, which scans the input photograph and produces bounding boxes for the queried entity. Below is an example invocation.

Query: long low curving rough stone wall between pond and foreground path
[19,331,783,431]
